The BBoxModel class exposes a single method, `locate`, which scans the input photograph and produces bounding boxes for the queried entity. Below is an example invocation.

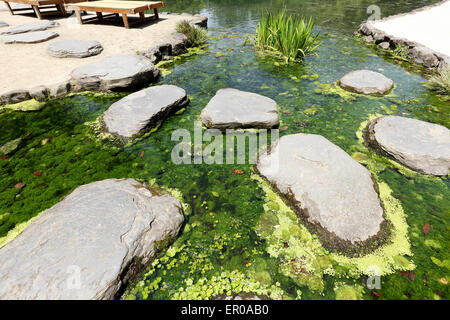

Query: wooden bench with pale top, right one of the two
[66,0,164,29]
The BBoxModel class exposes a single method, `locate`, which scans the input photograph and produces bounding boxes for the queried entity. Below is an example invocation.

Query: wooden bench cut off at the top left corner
[3,0,85,19]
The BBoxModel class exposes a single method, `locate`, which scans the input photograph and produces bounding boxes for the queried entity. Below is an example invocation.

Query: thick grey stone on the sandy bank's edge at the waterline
[71,55,159,91]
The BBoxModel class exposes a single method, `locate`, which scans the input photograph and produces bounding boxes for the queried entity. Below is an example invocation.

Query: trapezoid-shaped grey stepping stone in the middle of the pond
[200,88,280,129]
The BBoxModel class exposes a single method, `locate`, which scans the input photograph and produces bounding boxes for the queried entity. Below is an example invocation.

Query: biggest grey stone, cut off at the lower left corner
[0,179,184,300]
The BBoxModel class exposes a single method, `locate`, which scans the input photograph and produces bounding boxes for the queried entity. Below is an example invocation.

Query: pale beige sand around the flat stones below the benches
[0,11,190,94]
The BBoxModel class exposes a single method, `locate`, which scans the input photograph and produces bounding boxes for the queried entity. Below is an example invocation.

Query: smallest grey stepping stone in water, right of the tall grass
[339,70,394,95]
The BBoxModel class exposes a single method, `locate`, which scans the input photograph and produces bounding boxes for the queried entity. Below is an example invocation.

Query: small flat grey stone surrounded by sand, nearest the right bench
[47,40,103,58]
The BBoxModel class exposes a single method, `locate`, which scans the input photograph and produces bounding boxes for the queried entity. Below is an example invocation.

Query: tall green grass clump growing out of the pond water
[256,10,320,62]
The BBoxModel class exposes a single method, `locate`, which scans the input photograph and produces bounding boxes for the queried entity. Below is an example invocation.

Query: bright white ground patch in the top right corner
[371,1,450,56]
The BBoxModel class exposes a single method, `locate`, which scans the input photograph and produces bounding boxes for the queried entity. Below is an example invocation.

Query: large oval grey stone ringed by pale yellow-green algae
[256,133,383,244]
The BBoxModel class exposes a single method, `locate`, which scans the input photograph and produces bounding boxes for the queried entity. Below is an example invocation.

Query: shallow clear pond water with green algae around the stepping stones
[0,0,450,299]
